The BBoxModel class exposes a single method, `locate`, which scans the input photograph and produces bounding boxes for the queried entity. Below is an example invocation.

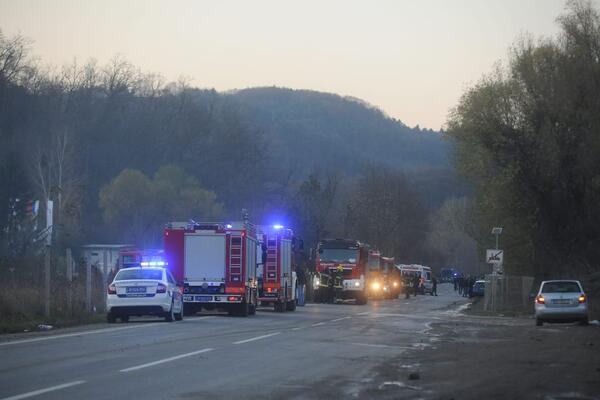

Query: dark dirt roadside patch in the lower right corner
[361,318,600,400]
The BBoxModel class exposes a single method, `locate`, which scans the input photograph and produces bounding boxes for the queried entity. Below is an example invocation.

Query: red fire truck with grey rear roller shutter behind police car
[164,221,260,317]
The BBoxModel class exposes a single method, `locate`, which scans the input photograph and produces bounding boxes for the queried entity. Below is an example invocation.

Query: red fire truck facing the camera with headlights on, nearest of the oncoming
[313,239,369,304]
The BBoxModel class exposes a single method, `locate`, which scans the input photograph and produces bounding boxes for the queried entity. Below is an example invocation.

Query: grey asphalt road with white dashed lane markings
[0,285,596,399]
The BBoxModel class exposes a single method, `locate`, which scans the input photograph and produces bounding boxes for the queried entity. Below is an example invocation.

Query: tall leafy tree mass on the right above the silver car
[448,1,600,275]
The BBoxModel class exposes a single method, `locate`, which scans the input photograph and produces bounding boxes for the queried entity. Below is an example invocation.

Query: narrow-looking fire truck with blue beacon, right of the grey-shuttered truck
[257,225,301,312]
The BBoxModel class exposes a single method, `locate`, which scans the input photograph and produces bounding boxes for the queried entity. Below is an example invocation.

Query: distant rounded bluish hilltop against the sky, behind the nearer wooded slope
[229,87,448,174]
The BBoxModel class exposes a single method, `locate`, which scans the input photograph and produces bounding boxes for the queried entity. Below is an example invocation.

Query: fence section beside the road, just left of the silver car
[483,274,534,311]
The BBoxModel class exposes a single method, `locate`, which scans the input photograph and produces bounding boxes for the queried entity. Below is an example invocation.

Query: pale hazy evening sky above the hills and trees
[0,0,584,129]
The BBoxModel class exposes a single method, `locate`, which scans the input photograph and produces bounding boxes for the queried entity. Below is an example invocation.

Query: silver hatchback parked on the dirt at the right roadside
[535,280,588,326]
